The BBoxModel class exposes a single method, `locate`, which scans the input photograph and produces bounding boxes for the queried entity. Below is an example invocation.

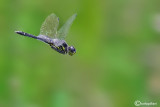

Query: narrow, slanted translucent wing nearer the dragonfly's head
[56,14,77,40]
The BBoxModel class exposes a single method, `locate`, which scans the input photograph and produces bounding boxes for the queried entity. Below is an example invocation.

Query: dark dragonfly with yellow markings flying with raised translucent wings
[15,13,77,56]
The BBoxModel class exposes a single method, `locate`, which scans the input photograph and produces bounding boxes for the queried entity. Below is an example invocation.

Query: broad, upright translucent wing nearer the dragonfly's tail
[40,13,59,38]
